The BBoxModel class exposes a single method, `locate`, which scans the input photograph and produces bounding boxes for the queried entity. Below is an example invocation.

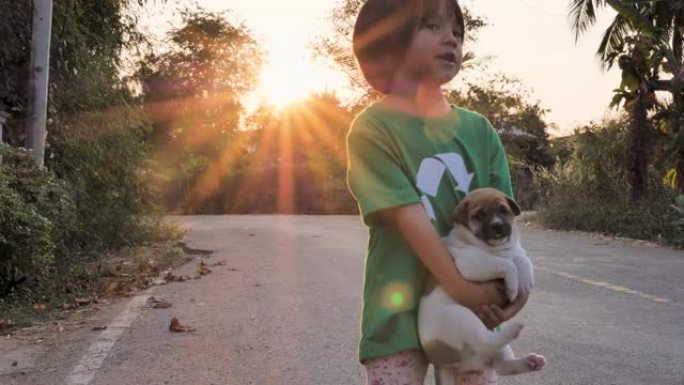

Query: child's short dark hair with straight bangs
[352,0,465,94]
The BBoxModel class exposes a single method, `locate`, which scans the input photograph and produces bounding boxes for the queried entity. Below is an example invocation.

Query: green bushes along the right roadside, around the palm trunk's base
[535,121,680,244]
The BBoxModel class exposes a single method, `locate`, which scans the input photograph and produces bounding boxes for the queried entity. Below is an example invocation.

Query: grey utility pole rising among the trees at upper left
[26,0,52,166]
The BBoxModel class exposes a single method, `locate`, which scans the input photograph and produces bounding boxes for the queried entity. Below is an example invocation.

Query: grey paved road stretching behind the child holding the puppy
[0,216,684,385]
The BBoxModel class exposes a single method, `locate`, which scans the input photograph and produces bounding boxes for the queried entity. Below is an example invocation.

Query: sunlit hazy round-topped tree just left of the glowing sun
[139,9,263,213]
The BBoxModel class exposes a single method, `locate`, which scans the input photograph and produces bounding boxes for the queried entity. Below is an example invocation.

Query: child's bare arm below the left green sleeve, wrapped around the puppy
[378,203,508,328]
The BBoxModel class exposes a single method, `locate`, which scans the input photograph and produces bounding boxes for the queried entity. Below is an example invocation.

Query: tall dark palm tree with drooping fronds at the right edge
[570,0,684,195]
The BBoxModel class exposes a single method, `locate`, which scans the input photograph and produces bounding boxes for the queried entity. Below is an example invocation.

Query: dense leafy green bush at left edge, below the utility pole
[0,145,74,296]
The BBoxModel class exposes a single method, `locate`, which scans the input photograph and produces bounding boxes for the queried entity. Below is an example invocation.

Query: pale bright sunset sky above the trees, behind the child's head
[150,0,620,135]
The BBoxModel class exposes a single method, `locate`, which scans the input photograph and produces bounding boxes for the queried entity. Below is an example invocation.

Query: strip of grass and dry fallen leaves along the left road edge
[0,225,196,334]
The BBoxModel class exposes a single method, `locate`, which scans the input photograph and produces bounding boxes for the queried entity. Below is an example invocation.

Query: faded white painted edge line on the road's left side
[65,291,151,385]
